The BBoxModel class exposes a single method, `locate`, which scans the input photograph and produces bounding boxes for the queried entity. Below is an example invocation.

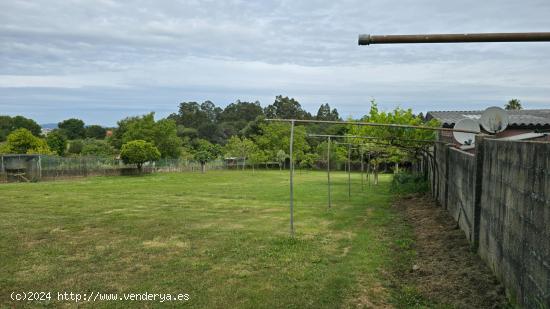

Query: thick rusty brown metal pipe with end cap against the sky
[358,32,550,45]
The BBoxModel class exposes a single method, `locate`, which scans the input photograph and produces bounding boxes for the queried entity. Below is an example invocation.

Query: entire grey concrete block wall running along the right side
[428,139,550,308]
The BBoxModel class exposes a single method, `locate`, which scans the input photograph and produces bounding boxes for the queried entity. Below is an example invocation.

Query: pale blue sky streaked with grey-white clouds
[0,0,550,126]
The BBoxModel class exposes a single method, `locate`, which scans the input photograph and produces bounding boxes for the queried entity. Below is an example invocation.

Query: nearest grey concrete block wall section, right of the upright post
[478,139,550,308]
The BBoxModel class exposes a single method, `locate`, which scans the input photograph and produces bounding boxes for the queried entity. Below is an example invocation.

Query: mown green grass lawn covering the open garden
[0,171,410,308]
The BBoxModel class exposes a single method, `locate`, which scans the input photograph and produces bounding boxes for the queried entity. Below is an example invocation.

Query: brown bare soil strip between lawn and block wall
[395,196,509,308]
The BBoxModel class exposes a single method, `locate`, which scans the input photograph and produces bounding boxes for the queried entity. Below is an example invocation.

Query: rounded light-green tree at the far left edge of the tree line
[0,128,53,154]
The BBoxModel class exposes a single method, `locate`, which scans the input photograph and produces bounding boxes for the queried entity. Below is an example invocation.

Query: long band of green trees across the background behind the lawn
[0,95,435,172]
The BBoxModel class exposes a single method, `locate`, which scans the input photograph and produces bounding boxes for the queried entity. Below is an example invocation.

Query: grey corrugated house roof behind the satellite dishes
[426,109,550,127]
